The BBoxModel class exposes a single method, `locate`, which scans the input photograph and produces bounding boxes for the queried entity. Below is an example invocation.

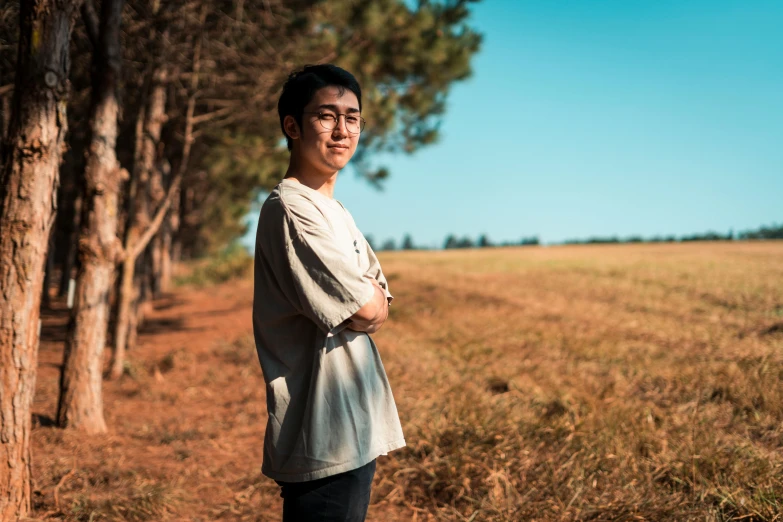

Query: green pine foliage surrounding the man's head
[176,0,481,256]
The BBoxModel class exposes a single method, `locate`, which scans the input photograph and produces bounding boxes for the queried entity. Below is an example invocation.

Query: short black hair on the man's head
[277,63,362,150]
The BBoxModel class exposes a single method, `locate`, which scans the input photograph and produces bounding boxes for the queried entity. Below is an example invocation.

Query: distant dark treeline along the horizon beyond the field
[367,220,783,251]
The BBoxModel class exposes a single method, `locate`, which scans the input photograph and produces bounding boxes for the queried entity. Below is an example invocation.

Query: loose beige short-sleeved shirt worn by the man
[253,179,405,482]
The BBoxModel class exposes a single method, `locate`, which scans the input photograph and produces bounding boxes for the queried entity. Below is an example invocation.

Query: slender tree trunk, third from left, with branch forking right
[109,67,167,379]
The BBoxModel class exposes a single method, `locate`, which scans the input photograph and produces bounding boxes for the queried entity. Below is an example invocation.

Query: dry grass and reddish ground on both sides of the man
[27,242,783,521]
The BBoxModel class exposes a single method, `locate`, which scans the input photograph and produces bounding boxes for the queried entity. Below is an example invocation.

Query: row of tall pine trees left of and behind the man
[0,0,480,520]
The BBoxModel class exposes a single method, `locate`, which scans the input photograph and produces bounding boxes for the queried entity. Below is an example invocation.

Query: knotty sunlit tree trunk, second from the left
[57,0,125,433]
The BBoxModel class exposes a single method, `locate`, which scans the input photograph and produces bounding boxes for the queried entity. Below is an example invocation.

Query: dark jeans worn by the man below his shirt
[275,460,375,522]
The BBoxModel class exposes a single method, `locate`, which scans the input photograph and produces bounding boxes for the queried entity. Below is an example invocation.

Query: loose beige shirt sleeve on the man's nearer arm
[286,193,375,333]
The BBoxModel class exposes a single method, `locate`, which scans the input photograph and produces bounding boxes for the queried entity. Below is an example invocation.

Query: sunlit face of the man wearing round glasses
[286,86,360,175]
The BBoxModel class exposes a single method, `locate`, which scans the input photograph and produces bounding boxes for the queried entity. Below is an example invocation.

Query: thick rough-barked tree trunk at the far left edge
[0,0,79,520]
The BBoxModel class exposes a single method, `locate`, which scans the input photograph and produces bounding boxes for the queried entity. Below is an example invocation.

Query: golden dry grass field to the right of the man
[374,243,783,521]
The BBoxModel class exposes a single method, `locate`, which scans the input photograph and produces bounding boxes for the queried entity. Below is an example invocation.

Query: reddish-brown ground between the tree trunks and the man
[33,281,410,521]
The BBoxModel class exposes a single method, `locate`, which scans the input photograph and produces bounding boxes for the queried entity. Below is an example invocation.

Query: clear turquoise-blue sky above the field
[248,0,783,247]
